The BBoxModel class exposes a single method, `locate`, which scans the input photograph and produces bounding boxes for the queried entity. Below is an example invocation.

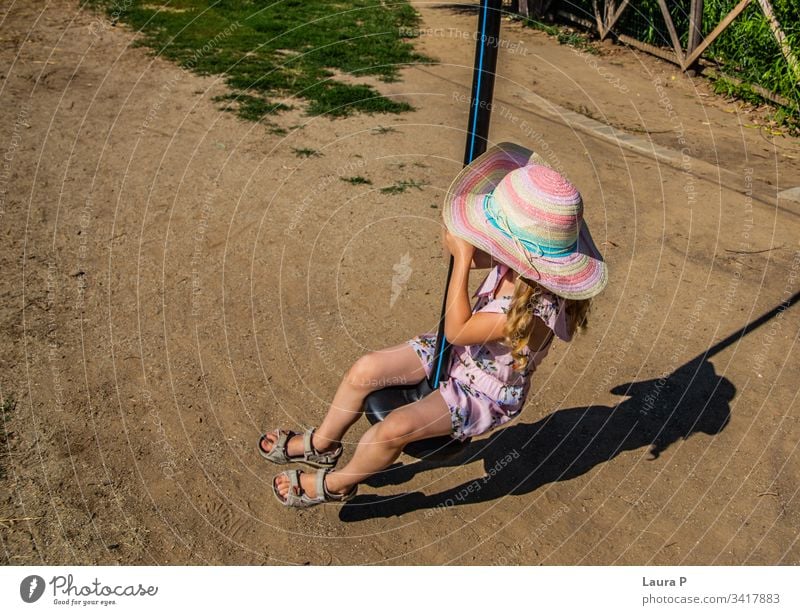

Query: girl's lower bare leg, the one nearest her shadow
[275,390,451,498]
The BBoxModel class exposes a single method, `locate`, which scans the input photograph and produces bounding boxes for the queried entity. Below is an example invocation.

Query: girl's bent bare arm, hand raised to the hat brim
[444,231,506,346]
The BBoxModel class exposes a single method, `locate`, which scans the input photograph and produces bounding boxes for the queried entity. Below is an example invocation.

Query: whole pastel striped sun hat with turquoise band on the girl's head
[443,143,608,299]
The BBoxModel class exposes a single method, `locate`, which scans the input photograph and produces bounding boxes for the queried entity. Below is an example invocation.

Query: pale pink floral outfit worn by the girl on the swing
[407,265,570,440]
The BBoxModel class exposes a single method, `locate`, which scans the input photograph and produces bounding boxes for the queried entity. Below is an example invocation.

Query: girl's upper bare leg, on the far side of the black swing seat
[261,343,425,455]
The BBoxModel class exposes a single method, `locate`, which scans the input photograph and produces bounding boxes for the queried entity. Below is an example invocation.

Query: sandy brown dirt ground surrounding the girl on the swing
[0,0,800,565]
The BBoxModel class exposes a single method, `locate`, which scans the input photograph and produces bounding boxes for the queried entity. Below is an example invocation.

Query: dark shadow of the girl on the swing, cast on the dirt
[340,355,736,521]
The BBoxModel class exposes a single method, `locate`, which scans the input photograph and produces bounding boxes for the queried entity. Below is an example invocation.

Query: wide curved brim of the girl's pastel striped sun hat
[442,143,608,299]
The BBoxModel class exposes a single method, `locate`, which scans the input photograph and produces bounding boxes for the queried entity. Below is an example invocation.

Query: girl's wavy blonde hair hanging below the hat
[503,276,592,372]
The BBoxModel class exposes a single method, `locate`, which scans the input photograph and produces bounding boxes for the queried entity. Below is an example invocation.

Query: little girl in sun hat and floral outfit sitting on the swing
[258,143,608,507]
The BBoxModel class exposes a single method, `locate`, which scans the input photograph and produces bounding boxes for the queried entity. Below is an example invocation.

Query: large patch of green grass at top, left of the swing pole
[83,0,431,120]
